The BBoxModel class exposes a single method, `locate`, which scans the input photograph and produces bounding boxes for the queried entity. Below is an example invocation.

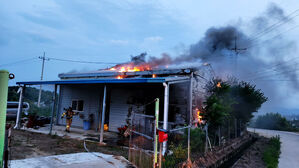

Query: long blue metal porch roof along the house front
[17,77,189,85]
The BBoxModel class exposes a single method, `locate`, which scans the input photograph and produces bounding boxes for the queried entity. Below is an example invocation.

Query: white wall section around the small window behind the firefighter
[58,85,103,129]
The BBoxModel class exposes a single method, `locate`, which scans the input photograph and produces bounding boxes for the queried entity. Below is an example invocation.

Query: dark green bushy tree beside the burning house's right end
[203,79,268,139]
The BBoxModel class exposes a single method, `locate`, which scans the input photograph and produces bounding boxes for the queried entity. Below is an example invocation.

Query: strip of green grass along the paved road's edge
[263,136,281,168]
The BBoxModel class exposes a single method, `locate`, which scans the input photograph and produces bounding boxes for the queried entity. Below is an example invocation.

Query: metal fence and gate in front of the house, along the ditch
[129,99,245,168]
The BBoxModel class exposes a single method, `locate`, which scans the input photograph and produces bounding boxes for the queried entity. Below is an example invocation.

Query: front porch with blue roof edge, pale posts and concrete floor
[16,77,192,146]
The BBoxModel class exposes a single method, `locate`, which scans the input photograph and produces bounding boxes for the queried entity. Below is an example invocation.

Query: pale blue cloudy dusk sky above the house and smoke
[0,0,299,114]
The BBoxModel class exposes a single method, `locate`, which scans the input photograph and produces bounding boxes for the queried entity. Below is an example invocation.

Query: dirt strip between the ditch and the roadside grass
[232,137,269,168]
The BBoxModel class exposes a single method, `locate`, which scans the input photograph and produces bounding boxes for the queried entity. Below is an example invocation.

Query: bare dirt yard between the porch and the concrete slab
[10,130,128,160]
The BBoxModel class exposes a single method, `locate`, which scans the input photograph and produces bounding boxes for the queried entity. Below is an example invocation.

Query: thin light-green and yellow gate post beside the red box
[153,98,159,168]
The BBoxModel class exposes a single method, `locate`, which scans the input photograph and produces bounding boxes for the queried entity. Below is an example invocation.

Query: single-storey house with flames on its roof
[17,58,206,142]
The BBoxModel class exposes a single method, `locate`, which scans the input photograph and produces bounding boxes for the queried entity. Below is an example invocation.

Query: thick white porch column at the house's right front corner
[162,83,169,155]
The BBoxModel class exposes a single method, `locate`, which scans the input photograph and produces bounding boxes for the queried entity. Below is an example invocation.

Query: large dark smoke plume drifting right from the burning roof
[149,4,299,113]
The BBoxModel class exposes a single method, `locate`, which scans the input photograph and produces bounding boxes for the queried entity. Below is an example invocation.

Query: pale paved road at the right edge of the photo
[248,128,299,168]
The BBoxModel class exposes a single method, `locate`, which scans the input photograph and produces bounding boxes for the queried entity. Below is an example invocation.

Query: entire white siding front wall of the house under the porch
[58,83,188,132]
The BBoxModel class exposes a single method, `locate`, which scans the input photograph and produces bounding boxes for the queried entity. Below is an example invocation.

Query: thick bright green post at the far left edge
[0,70,9,167]
